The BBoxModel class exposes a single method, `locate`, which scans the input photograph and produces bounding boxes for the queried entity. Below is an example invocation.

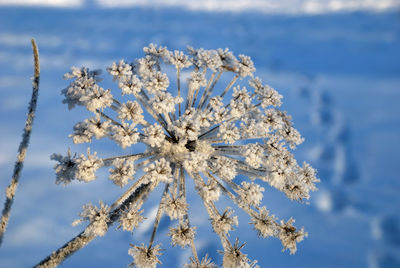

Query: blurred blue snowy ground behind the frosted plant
[0,0,400,268]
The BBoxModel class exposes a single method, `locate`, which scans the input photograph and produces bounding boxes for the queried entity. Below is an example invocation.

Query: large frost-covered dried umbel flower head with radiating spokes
[52,44,318,267]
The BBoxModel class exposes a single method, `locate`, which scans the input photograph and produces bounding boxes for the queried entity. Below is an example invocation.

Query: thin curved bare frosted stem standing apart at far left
[0,39,40,246]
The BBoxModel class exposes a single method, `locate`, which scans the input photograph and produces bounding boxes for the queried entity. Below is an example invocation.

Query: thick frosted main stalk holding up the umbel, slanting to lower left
[34,183,152,268]
